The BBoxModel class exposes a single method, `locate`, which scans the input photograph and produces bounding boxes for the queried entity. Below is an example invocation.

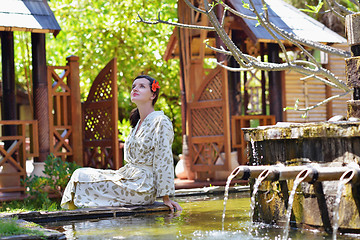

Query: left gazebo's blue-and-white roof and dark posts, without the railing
[0,0,61,162]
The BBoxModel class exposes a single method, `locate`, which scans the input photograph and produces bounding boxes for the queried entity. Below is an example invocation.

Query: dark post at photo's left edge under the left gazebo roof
[1,32,17,139]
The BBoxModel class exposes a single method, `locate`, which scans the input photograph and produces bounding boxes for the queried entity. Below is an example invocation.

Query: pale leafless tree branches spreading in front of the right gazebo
[139,0,352,112]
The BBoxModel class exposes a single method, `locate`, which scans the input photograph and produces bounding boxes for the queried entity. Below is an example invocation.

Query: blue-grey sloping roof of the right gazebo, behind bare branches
[228,0,347,43]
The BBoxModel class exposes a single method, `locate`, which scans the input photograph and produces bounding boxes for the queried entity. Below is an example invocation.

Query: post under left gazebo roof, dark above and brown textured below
[31,33,50,162]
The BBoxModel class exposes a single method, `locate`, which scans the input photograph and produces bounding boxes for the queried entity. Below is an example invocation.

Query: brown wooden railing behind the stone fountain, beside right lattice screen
[231,115,275,165]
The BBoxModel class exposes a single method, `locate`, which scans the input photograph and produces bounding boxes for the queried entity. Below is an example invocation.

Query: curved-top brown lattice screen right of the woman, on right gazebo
[189,68,230,177]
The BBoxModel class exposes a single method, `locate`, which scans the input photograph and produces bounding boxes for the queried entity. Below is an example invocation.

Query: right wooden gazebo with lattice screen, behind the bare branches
[164,0,347,180]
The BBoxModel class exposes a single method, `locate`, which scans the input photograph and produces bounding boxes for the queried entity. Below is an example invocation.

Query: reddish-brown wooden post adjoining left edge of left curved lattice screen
[66,56,83,166]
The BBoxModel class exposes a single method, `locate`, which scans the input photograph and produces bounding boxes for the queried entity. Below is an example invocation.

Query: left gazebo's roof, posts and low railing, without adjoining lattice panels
[0,0,61,199]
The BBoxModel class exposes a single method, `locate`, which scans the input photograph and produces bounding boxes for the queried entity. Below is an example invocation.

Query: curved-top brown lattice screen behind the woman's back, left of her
[83,59,122,169]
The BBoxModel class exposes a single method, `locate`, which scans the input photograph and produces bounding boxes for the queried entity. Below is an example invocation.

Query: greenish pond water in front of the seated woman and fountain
[44,193,360,240]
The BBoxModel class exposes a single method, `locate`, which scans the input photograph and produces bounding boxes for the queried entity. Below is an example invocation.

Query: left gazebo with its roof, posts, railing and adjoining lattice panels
[0,0,122,201]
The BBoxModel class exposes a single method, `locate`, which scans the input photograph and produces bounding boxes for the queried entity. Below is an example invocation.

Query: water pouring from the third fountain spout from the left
[283,168,312,240]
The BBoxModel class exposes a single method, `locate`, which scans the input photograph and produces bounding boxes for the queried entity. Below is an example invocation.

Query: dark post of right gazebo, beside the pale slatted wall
[268,43,284,122]
